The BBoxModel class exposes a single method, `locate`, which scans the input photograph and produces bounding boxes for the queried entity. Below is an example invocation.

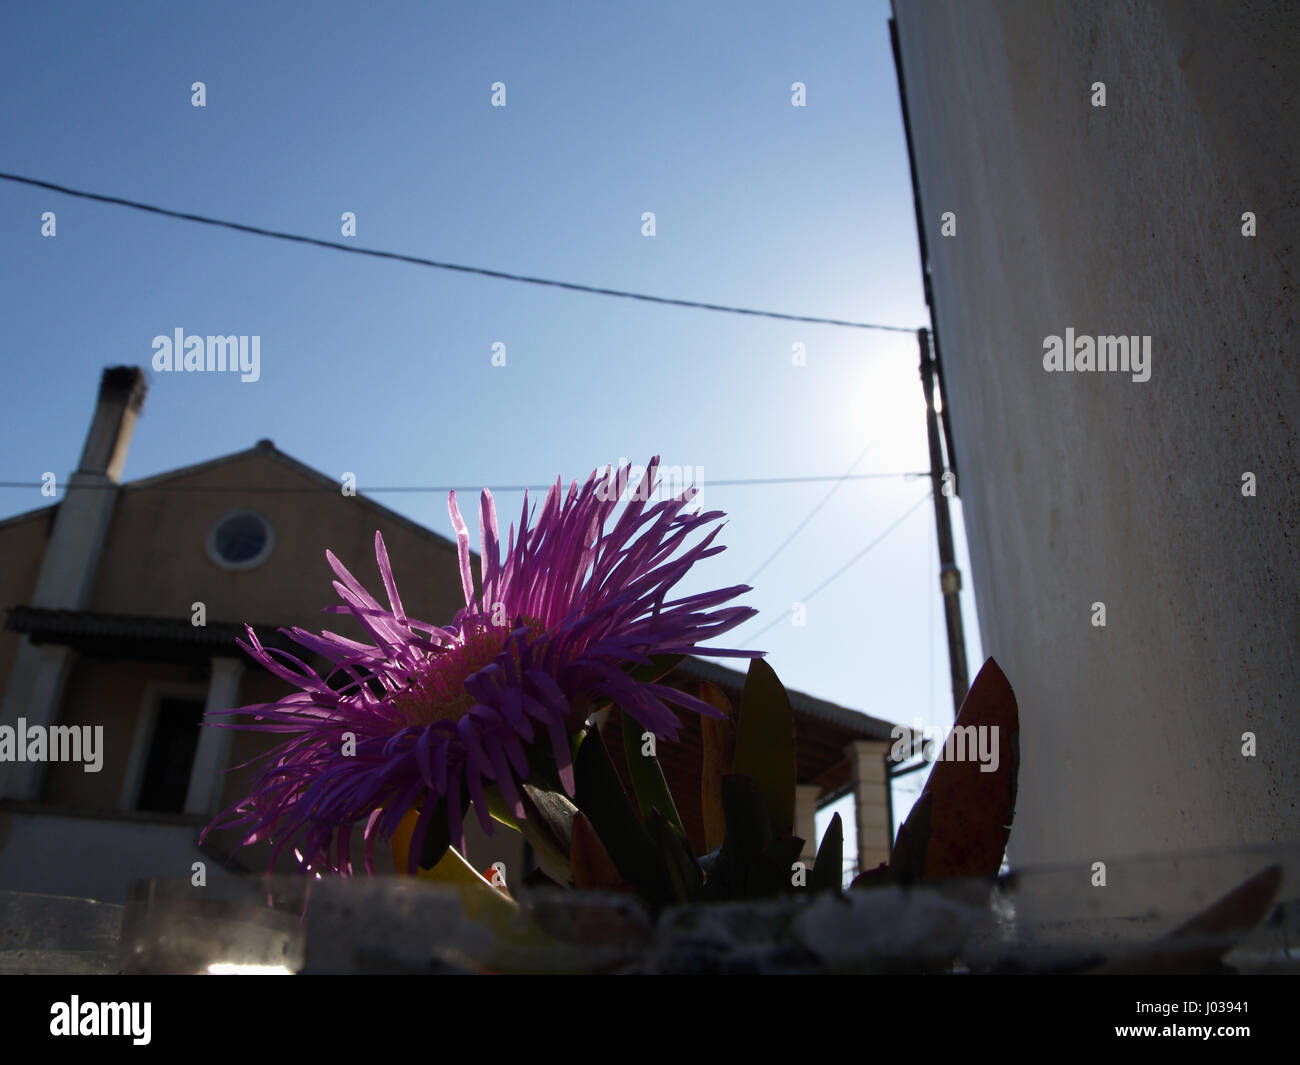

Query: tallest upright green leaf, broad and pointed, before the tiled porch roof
[736,658,796,836]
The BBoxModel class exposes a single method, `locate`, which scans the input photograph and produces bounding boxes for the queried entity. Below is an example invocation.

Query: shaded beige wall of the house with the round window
[0,451,523,883]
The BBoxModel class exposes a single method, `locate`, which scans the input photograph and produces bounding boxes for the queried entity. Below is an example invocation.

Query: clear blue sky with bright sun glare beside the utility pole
[0,0,983,868]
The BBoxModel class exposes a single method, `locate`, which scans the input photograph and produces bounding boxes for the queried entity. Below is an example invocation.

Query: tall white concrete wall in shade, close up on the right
[896,0,1300,865]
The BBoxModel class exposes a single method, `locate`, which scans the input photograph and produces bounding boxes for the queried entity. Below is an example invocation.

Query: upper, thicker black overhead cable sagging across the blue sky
[0,172,917,333]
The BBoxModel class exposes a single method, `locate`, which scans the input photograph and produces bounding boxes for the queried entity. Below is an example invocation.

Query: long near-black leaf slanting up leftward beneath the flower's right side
[573,730,672,910]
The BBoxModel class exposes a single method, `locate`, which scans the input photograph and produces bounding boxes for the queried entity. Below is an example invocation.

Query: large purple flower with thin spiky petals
[203,458,759,874]
